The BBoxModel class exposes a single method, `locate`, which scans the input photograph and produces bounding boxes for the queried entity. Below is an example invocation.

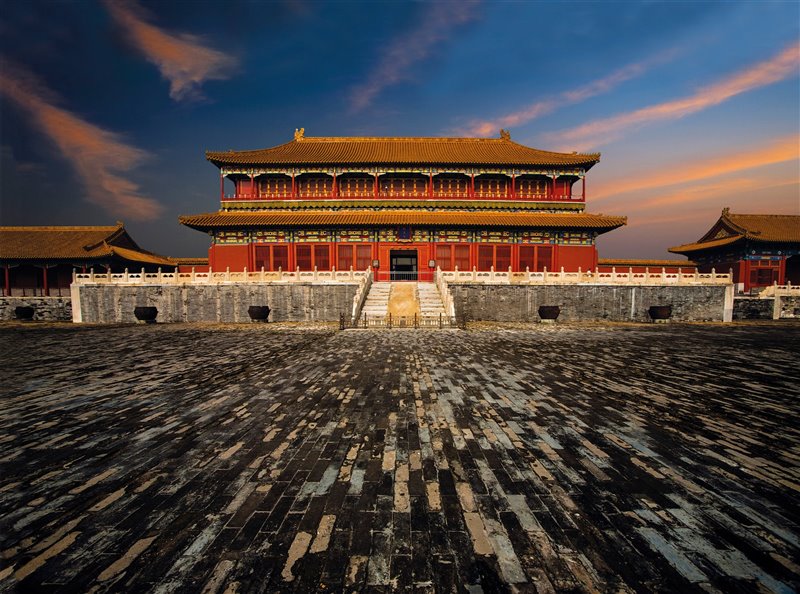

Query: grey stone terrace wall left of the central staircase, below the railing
[72,282,358,323]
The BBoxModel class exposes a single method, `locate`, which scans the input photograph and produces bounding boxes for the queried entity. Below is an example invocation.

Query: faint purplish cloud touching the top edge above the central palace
[350,0,478,111]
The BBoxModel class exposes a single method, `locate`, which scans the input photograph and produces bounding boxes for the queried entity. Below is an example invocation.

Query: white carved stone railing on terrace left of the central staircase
[72,268,372,285]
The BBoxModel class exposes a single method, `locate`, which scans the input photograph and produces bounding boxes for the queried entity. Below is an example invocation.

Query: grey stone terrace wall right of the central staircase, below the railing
[449,283,733,322]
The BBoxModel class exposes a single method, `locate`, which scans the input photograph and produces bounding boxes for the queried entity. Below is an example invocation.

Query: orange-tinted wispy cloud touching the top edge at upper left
[105,0,237,101]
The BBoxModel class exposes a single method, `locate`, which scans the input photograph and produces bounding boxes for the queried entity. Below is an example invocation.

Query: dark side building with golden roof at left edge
[0,223,175,295]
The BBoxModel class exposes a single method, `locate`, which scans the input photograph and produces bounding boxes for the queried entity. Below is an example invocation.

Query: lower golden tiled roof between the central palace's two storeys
[179,210,627,231]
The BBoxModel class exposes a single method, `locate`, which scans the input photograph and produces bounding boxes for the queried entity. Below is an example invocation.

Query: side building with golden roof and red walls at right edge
[669,208,800,292]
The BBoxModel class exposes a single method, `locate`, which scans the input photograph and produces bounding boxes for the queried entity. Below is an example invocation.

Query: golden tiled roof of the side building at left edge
[0,223,172,266]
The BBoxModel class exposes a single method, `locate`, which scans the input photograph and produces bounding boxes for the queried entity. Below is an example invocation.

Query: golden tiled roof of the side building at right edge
[668,208,800,254]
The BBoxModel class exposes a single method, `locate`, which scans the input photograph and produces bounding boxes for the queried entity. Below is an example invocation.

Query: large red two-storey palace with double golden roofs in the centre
[180,129,626,280]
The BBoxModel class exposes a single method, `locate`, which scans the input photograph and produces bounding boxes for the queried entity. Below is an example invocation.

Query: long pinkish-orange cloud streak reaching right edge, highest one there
[545,43,800,150]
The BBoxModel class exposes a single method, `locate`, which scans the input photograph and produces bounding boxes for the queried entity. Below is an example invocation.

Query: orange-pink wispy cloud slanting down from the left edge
[0,62,162,221]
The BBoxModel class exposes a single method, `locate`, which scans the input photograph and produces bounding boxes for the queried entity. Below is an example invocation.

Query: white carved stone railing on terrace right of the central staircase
[436,268,733,284]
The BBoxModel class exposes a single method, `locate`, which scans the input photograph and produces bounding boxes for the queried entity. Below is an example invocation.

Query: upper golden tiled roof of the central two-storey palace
[206,134,600,169]
